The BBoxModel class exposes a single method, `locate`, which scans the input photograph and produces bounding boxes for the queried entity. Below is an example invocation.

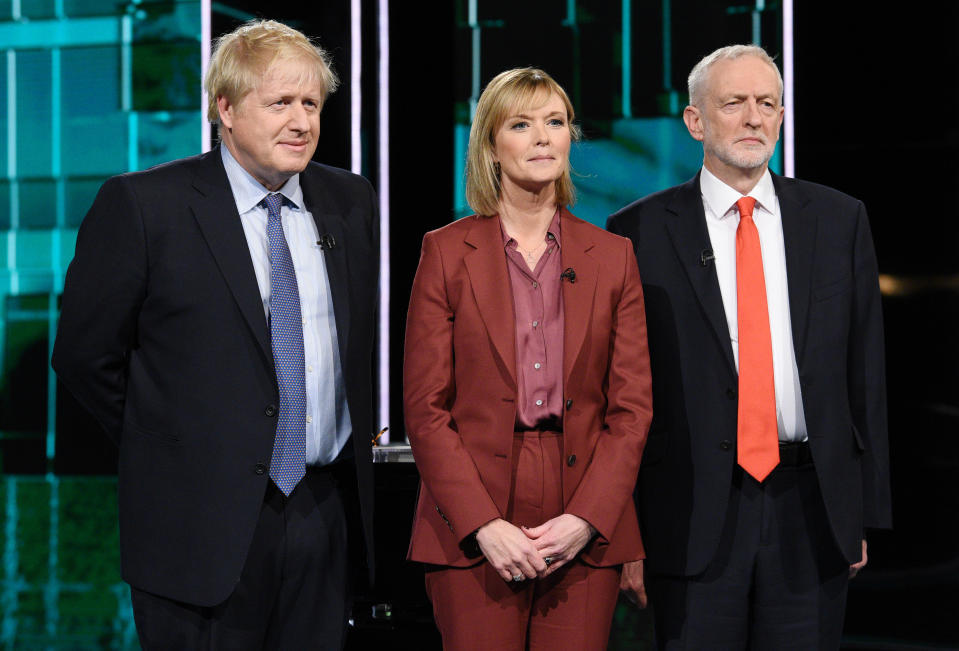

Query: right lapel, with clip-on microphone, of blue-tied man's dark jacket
[300,173,350,360]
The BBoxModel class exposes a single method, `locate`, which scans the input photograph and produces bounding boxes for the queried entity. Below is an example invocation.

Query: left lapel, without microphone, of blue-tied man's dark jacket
[191,148,273,370]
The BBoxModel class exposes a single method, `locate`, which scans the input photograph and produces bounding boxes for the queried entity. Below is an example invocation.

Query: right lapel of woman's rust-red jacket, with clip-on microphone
[559,208,599,393]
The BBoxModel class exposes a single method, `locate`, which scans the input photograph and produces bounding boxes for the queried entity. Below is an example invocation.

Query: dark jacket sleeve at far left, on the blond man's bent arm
[52,176,147,443]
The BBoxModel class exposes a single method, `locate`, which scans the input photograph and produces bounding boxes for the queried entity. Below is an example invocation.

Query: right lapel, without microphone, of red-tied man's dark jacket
[772,174,818,364]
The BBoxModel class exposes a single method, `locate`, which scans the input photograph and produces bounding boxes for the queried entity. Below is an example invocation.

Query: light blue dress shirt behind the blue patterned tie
[220,145,353,466]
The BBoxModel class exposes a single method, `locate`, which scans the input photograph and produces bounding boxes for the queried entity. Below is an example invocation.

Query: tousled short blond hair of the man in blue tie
[204,20,340,123]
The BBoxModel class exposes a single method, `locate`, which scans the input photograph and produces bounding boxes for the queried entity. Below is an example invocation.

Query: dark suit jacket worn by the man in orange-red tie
[607,174,892,575]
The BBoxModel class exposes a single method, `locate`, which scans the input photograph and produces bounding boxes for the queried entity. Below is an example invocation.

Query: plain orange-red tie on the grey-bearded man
[736,197,779,481]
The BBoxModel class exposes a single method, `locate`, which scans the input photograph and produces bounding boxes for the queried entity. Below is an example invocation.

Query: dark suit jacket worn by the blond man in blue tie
[53,149,378,606]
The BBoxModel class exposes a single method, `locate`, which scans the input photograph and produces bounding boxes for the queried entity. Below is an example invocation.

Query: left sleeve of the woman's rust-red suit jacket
[403,233,500,540]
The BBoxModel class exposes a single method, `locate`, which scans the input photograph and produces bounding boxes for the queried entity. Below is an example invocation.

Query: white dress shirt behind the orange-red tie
[699,167,807,441]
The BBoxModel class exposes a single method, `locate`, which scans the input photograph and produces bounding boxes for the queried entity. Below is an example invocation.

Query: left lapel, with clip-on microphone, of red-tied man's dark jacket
[666,174,736,375]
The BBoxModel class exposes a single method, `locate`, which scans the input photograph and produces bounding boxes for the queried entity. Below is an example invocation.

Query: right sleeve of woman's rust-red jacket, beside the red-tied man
[566,239,653,540]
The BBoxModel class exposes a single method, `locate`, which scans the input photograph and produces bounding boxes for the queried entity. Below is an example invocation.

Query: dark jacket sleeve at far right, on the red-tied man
[849,203,892,529]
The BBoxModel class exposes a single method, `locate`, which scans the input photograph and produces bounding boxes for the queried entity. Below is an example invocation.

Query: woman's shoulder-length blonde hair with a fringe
[466,68,581,217]
